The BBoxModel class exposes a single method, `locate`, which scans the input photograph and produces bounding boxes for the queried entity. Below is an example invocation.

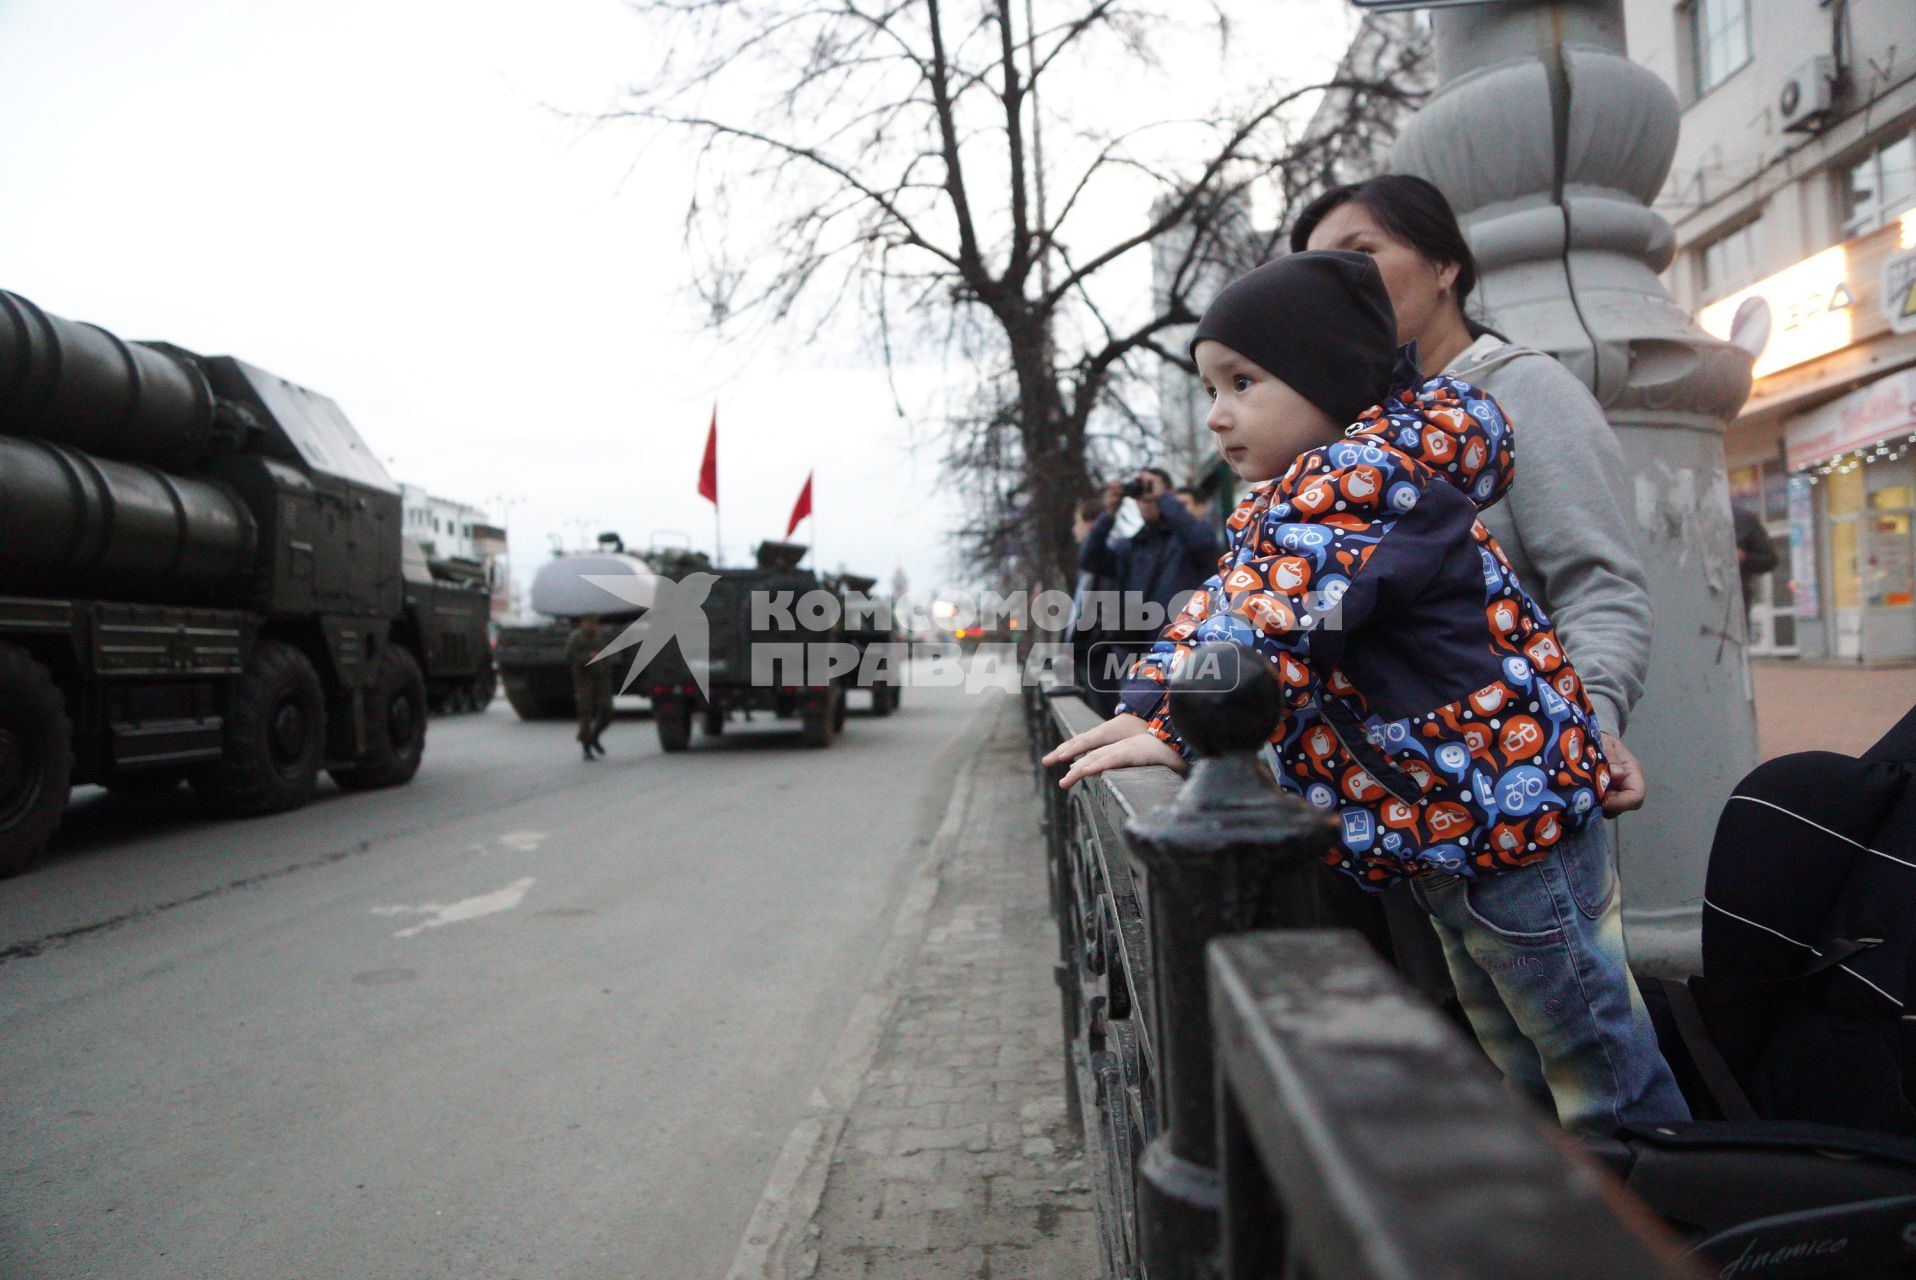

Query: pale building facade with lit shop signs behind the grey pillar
[1625,0,1916,661]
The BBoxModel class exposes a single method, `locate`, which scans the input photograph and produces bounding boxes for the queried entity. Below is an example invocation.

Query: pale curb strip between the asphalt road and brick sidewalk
[726,711,1002,1280]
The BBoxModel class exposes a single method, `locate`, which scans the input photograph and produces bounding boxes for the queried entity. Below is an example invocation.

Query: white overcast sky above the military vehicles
[0,0,1355,601]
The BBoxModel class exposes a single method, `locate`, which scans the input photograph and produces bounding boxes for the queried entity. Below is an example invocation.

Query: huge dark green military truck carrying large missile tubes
[0,293,425,872]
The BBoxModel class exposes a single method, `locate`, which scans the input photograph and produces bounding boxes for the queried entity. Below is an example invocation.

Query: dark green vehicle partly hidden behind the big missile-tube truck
[400,538,498,713]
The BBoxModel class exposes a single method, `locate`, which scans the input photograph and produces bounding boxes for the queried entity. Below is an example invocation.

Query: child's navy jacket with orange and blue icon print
[1119,354,1609,887]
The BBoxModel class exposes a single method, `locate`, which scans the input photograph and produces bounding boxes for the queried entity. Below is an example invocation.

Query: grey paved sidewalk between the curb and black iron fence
[758,697,1098,1280]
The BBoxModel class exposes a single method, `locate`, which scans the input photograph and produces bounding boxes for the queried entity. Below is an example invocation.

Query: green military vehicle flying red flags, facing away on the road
[634,542,856,751]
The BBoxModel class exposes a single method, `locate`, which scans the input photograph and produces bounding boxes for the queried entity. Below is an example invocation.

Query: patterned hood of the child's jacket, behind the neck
[1345,343,1517,510]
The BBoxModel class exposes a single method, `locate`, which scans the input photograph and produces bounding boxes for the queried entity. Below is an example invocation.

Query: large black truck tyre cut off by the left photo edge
[0,644,73,876]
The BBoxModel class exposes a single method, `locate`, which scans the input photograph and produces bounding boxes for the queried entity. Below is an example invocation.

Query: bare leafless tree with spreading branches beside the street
[615,0,1424,583]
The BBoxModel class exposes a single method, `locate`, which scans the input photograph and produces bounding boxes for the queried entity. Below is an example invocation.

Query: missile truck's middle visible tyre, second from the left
[194,640,326,816]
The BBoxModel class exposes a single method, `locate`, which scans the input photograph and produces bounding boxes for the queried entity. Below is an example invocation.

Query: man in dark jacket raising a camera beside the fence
[1079,468,1224,690]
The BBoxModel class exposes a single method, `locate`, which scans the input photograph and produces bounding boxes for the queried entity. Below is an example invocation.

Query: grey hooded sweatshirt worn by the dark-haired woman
[1443,333,1650,738]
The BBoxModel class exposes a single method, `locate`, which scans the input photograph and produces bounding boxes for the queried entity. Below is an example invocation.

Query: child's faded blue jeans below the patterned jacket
[1410,822,1690,1134]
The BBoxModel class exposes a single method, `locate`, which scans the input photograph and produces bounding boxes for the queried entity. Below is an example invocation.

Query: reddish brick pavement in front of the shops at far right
[1749,659,1916,759]
